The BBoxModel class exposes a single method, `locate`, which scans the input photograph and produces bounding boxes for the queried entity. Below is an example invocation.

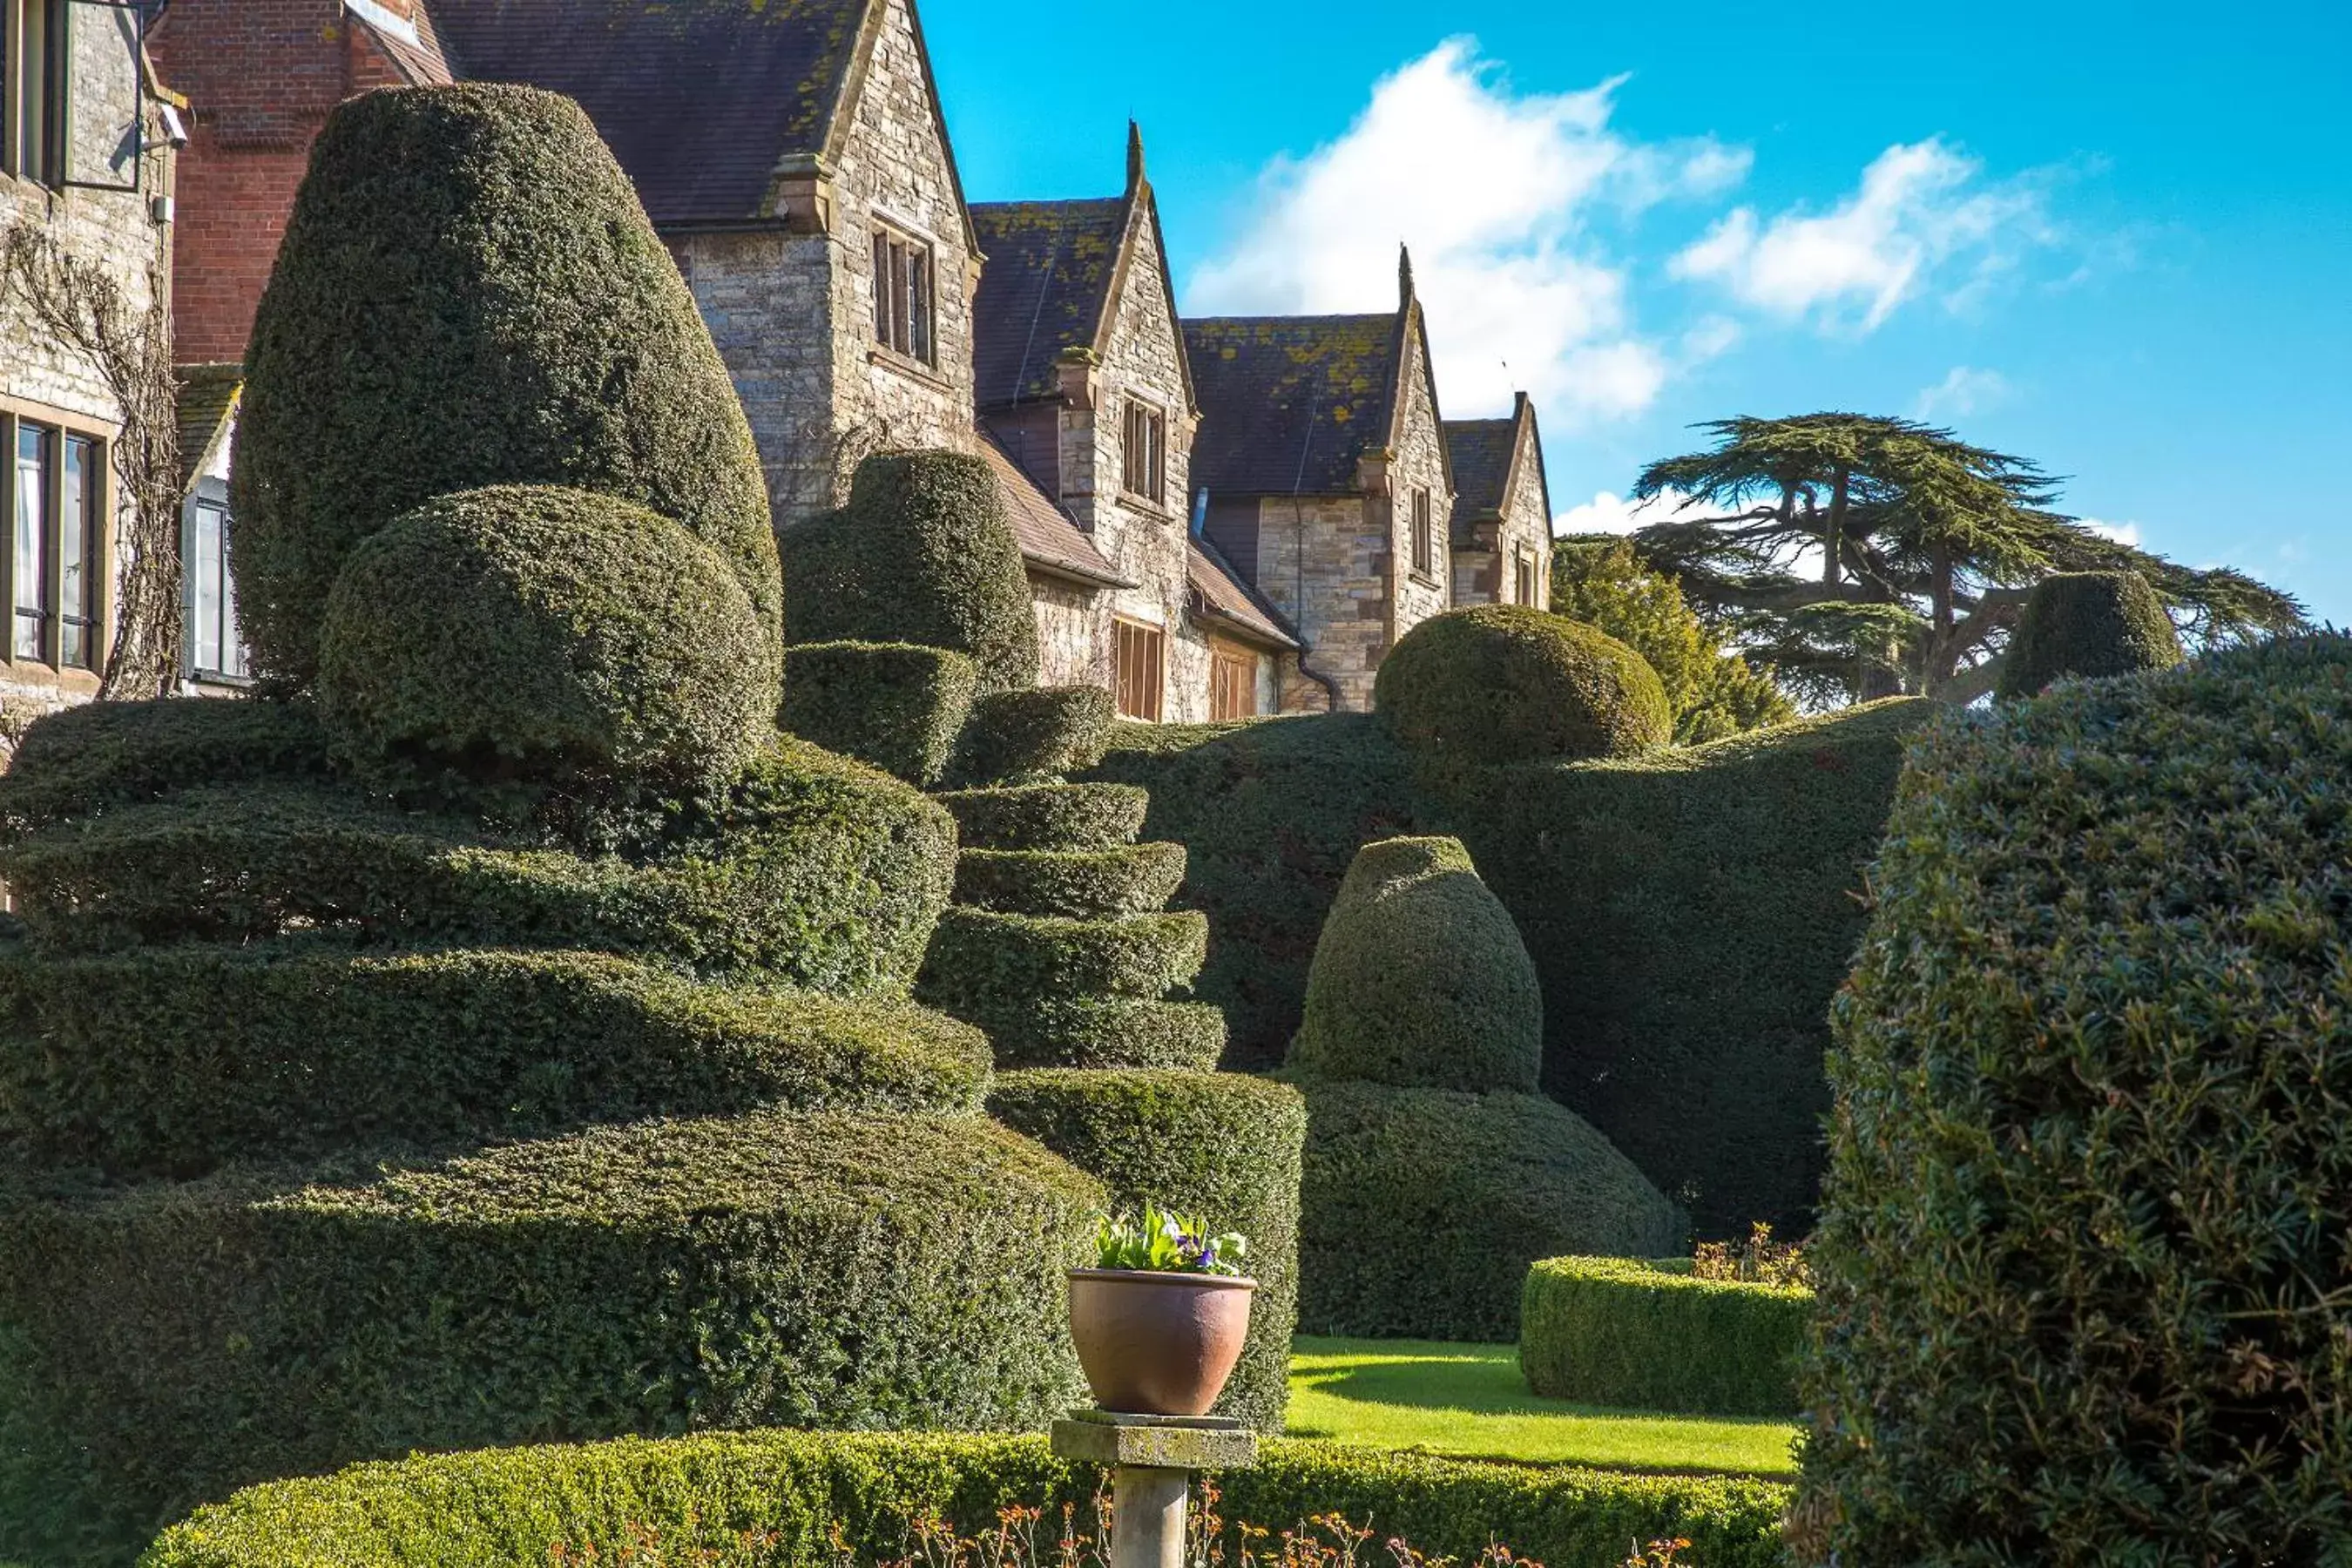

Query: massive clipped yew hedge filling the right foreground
[1800,637,2352,1564]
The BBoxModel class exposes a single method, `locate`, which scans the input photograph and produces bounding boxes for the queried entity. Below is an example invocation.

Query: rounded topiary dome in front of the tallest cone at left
[318,487,776,832]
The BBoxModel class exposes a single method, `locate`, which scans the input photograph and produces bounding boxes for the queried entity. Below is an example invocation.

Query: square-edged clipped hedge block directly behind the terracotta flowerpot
[988,1070,1308,1431]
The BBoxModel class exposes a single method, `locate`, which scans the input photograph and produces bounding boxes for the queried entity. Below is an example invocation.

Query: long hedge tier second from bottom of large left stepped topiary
[0,945,990,1175]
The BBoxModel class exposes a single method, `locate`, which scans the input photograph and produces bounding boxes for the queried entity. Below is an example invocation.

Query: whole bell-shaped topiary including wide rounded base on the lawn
[1284,839,1689,1340]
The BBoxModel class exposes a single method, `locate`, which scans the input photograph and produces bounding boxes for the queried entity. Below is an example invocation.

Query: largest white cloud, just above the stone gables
[1186,37,1750,430]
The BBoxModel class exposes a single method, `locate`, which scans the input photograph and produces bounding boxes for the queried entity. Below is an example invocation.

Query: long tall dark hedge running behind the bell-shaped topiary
[1089,700,1933,1251]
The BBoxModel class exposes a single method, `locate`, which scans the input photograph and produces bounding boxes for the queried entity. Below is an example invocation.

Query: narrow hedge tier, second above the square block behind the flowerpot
[915,909,1209,1018]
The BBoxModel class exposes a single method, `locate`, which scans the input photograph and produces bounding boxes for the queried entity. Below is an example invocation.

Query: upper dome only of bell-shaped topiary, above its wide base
[1289,839,1543,1093]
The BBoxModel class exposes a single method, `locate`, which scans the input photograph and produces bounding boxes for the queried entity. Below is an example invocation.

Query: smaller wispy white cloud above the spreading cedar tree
[1667,137,2056,332]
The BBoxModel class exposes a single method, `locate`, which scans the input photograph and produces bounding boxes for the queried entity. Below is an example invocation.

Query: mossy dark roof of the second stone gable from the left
[971,120,1193,411]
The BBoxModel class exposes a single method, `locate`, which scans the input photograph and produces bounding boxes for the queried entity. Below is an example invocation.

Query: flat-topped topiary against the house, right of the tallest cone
[781,451,1037,693]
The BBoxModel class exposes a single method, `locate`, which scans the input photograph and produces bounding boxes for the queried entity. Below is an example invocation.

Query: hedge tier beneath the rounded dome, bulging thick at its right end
[0,740,955,992]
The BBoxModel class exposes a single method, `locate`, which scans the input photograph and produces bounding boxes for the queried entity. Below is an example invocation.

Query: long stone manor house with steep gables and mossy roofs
[18,0,1550,721]
